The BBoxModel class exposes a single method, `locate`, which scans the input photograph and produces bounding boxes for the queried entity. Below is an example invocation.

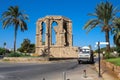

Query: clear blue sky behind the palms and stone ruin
[0,0,120,49]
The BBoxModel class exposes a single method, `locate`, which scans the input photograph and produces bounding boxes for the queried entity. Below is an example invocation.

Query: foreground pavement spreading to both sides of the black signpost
[59,63,119,80]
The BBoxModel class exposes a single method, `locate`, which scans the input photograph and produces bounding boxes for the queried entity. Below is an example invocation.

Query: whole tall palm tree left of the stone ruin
[2,6,28,52]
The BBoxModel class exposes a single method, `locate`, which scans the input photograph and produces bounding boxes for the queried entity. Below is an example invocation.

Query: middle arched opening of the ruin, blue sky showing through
[51,21,58,45]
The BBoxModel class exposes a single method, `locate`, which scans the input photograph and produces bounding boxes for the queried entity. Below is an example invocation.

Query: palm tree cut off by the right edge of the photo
[112,18,120,47]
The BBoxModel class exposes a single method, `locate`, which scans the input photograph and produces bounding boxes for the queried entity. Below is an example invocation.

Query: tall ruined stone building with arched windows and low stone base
[35,16,77,58]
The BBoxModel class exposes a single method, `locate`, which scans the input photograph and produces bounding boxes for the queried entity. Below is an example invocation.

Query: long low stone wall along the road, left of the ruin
[3,57,48,63]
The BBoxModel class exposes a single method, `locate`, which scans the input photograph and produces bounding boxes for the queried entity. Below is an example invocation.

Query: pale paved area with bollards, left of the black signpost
[61,64,103,80]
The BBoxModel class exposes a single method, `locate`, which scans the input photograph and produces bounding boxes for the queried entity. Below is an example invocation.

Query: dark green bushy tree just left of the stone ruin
[18,39,35,53]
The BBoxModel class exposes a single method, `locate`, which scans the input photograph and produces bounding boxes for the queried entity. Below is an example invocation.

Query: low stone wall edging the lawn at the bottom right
[101,60,120,79]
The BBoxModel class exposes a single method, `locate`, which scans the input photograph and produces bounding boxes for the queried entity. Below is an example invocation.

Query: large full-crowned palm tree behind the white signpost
[84,1,118,51]
